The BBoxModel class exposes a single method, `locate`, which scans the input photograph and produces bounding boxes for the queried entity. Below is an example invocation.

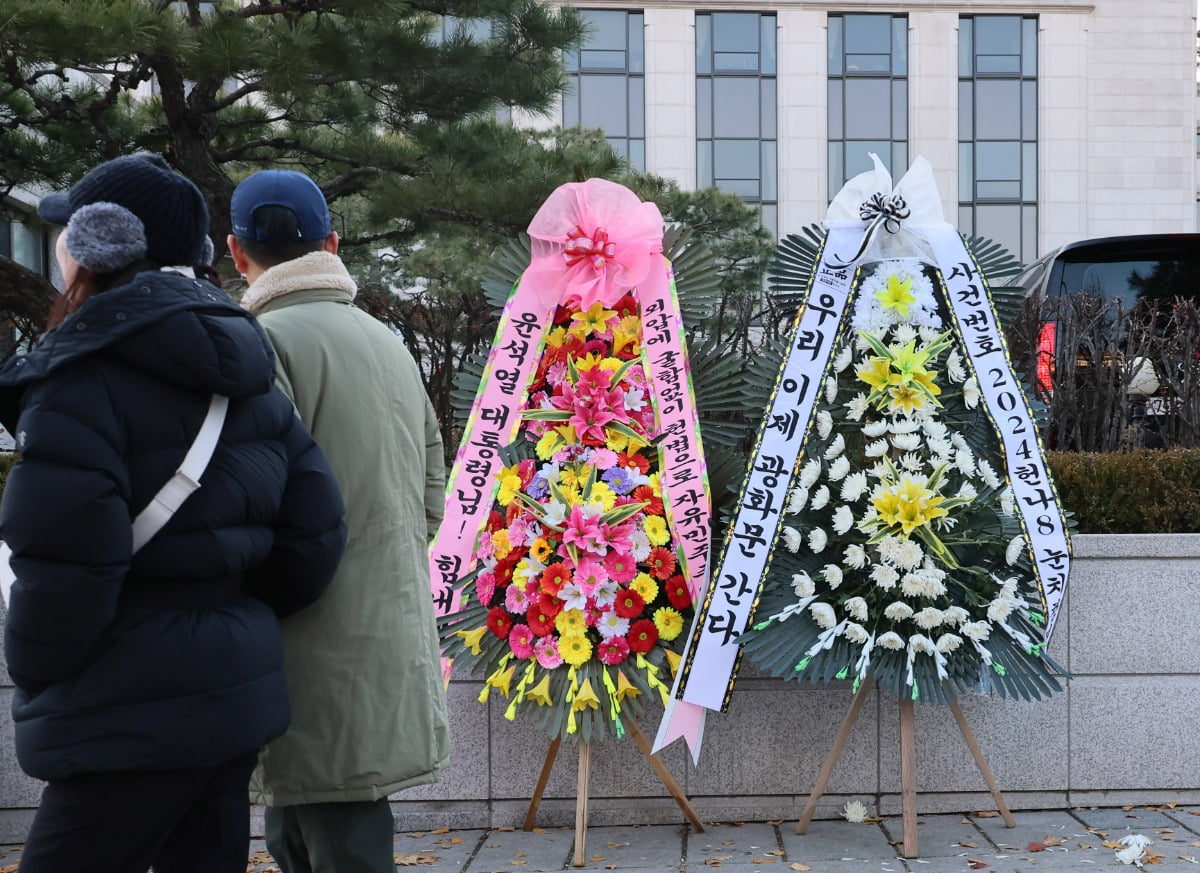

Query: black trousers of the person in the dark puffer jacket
[20,753,258,873]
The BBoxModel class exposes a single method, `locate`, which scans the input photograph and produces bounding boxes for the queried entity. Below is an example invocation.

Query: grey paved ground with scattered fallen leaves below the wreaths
[0,806,1200,873]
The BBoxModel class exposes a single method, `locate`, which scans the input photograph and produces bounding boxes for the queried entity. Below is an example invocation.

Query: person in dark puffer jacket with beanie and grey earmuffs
[0,155,346,873]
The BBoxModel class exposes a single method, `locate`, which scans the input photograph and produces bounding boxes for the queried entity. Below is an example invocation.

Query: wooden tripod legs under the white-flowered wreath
[796,676,1016,857]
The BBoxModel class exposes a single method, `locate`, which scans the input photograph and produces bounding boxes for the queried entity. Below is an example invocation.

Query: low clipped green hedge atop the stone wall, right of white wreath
[1049,448,1200,534]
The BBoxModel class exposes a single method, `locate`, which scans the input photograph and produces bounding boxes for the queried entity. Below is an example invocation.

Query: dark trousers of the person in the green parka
[264,797,396,873]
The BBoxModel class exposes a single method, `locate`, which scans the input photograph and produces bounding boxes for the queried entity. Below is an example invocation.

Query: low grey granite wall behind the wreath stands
[0,534,1200,843]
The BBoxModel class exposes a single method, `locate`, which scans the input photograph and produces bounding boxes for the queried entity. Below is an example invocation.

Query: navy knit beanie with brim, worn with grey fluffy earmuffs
[37,152,209,266]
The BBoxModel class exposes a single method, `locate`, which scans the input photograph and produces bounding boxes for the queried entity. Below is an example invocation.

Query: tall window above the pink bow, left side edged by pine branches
[563,10,646,170]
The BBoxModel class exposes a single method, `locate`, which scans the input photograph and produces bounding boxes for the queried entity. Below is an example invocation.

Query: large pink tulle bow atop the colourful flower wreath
[524,179,662,309]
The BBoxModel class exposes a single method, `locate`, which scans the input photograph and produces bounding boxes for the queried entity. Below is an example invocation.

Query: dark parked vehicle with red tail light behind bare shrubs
[1012,234,1200,450]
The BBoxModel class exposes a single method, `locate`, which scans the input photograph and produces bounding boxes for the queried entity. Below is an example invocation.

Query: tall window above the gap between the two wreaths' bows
[696,12,779,233]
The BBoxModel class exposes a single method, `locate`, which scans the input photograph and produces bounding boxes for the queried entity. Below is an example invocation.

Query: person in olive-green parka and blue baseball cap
[228,170,450,873]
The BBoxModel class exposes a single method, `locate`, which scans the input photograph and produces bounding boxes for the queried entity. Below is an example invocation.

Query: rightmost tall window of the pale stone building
[959,16,1038,261]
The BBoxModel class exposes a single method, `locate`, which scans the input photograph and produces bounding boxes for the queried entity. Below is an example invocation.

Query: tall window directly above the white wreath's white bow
[829,14,908,199]
